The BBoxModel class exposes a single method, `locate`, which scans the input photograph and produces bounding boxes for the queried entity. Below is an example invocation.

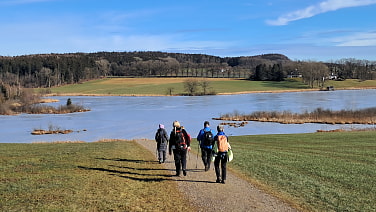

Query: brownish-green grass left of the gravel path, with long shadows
[0,141,194,211]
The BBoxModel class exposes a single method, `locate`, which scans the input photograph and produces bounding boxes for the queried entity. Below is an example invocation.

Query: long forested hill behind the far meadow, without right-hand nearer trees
[0,51,290,87]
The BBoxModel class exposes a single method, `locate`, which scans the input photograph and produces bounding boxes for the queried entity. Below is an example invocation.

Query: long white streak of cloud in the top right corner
[266,0,376,26]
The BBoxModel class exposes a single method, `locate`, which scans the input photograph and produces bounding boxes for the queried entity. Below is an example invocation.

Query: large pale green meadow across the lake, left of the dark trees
[42,78,308,95]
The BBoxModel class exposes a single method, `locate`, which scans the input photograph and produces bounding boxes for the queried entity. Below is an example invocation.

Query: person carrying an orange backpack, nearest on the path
[213,125,231,184]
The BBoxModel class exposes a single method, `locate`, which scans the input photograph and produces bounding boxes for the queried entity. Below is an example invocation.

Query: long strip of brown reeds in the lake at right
[216,107,376,124]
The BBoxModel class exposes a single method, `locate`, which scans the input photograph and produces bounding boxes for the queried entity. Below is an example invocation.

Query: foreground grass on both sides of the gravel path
[0,131,376,211]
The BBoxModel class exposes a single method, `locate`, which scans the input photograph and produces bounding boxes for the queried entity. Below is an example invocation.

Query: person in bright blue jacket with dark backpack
[197,121,215,171]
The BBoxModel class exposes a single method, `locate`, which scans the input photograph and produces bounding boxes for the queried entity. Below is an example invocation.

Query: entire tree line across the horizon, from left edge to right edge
[0,52,376,90]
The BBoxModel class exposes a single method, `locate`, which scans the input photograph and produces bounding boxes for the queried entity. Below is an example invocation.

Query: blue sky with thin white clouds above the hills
[0,0,376,61]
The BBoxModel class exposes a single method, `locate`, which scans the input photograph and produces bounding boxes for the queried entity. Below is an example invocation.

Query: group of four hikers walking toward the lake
[155,121,232,184]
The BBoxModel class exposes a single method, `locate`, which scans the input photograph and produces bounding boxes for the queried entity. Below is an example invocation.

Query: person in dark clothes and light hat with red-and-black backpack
[168,121,191,176]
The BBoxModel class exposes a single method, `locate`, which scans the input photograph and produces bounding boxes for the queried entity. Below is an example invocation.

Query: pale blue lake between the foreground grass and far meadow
[0,90,376,143]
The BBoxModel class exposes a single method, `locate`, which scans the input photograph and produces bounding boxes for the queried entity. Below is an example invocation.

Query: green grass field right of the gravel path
[230,131,376,211]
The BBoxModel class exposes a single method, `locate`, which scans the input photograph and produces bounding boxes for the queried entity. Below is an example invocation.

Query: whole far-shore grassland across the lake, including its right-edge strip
[41,78,376,95]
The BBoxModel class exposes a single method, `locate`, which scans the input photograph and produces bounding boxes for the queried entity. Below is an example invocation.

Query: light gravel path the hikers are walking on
[138,140,297,212]
